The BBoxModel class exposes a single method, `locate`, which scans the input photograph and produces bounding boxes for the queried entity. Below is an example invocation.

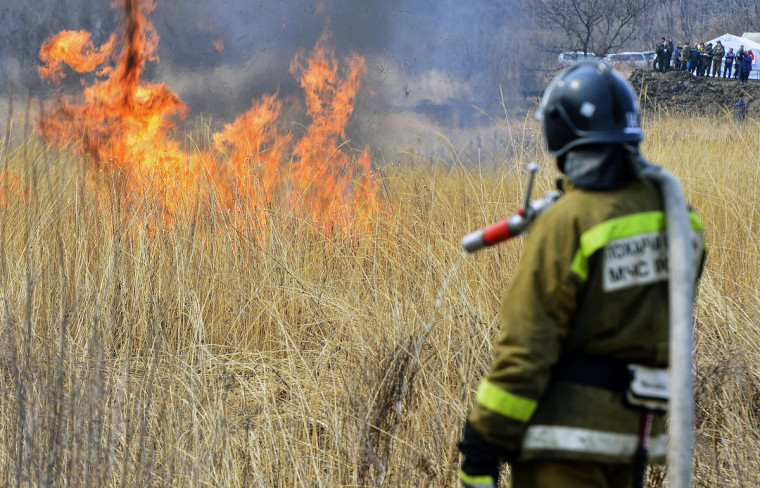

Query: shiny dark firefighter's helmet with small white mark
[539,60,644,157]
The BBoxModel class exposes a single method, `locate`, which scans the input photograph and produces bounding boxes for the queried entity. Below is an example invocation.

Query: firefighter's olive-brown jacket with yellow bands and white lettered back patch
[470,174,704,463]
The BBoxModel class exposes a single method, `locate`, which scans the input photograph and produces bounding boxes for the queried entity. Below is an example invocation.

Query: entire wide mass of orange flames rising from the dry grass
[39,0,380,229]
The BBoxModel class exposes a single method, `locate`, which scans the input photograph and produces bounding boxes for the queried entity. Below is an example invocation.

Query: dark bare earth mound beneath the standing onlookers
[629,70,760,118]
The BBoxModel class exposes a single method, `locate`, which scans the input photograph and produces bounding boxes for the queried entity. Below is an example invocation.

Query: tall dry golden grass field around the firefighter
[0,112,760,487]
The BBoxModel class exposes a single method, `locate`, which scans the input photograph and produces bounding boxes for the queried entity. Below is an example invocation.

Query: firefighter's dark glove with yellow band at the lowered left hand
[458,421,512,488]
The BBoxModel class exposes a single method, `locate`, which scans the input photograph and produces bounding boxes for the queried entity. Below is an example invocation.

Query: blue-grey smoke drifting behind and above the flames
[0,0,531,155]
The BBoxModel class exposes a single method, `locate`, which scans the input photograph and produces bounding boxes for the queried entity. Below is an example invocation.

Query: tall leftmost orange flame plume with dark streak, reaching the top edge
[38,0,193,209]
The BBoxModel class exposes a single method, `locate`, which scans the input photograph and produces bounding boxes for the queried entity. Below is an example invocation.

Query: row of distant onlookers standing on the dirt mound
[652,37,755,83]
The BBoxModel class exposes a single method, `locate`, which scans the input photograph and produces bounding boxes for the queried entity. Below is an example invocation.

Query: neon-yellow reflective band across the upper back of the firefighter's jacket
[570,210,706,281]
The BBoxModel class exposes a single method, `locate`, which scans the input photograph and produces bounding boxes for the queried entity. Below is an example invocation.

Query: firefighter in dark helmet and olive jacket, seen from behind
[459,61,702,488]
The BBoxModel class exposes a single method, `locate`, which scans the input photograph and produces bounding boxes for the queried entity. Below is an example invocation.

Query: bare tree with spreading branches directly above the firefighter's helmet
[537,0,662,56]
